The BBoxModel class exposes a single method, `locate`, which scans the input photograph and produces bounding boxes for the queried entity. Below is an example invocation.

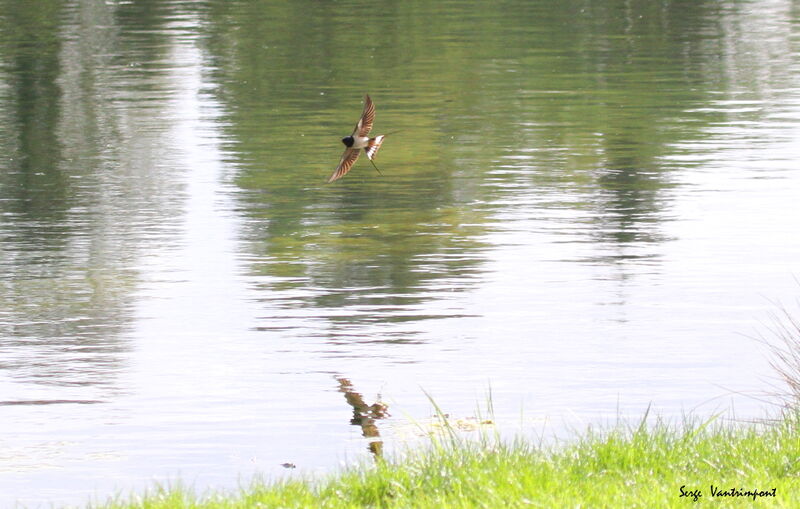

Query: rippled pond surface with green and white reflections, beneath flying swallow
[0,0,800,507]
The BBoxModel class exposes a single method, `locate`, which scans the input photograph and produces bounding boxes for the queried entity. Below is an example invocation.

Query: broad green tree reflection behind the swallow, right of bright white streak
[198,0,780,321]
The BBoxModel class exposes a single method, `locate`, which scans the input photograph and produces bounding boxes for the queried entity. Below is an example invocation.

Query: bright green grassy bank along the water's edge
[95,414,800,509]
